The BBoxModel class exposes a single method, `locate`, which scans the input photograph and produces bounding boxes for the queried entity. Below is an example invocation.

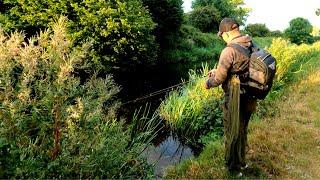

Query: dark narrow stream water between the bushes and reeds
[115,62,209,178]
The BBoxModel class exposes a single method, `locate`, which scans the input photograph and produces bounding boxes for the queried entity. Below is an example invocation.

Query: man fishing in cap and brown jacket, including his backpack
[205,18,276,176]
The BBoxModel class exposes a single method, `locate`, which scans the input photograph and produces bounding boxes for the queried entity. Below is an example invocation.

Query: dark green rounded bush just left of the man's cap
[189,6,221,32]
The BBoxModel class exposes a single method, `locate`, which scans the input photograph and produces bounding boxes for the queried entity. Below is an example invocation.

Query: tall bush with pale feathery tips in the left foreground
[0,18,152,179]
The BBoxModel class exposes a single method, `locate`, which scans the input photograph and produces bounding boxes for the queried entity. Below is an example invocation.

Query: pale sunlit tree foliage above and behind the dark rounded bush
[192,0,250,26]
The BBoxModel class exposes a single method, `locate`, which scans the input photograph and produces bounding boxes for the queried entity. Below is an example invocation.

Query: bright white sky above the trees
[183,0,320,31]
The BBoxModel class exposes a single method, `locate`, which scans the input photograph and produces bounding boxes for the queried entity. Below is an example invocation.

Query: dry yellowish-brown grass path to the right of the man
[248,65,320,179]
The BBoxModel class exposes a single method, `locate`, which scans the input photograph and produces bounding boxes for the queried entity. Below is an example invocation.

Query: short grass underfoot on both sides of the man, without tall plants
[166,58,320,179]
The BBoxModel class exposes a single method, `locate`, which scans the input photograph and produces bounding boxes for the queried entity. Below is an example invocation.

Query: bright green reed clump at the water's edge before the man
[159,66,222,143]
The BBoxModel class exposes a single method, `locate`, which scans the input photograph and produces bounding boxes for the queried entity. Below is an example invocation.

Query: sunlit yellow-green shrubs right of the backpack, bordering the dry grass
[257,38,320,117]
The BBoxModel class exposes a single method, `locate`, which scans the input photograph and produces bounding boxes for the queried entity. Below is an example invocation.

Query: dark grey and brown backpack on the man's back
[230,44,277,99]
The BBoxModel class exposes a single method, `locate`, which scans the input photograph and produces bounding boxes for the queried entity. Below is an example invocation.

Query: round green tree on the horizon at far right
[284,17,313,44]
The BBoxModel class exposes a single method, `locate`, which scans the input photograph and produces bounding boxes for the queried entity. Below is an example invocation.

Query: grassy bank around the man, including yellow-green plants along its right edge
[166,39,320,179]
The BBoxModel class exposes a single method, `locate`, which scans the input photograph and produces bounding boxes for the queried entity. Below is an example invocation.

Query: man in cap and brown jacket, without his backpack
[205,18,257,176]
